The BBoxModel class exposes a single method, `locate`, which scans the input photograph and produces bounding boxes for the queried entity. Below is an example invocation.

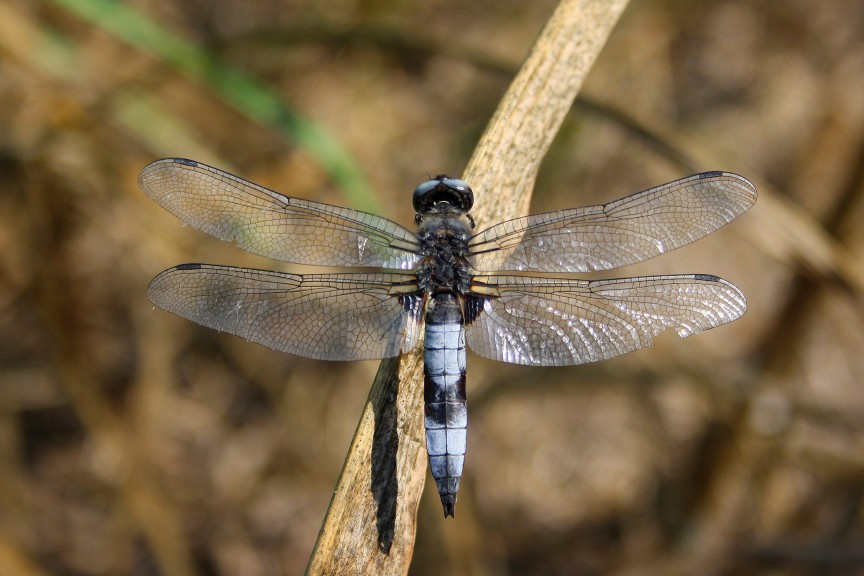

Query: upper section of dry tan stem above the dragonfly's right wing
[464,0,627,229]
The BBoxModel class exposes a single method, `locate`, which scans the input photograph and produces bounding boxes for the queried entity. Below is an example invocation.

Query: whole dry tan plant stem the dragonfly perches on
[306,0,627,576]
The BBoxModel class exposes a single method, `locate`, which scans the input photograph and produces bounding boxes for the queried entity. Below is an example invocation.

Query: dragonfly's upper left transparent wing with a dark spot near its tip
[138,158,420,270]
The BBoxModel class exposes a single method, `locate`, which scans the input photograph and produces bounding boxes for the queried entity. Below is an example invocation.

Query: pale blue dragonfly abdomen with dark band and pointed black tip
[424,293,468,516]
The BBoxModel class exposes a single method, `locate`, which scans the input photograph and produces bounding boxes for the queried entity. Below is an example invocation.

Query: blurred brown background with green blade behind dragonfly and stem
[0,0,864,576]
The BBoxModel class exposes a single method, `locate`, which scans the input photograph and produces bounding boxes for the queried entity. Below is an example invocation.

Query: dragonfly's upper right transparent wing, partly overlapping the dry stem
[469,172,756,272]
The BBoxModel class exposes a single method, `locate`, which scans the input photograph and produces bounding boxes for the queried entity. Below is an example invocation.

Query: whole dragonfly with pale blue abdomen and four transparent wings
[138,158,757,517]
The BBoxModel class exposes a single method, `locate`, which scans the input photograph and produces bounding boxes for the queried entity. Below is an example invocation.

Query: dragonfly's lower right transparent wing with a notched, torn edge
[465,274,747,366]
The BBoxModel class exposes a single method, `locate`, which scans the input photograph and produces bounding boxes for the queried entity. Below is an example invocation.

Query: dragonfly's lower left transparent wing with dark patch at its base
[147,264,423,360]
